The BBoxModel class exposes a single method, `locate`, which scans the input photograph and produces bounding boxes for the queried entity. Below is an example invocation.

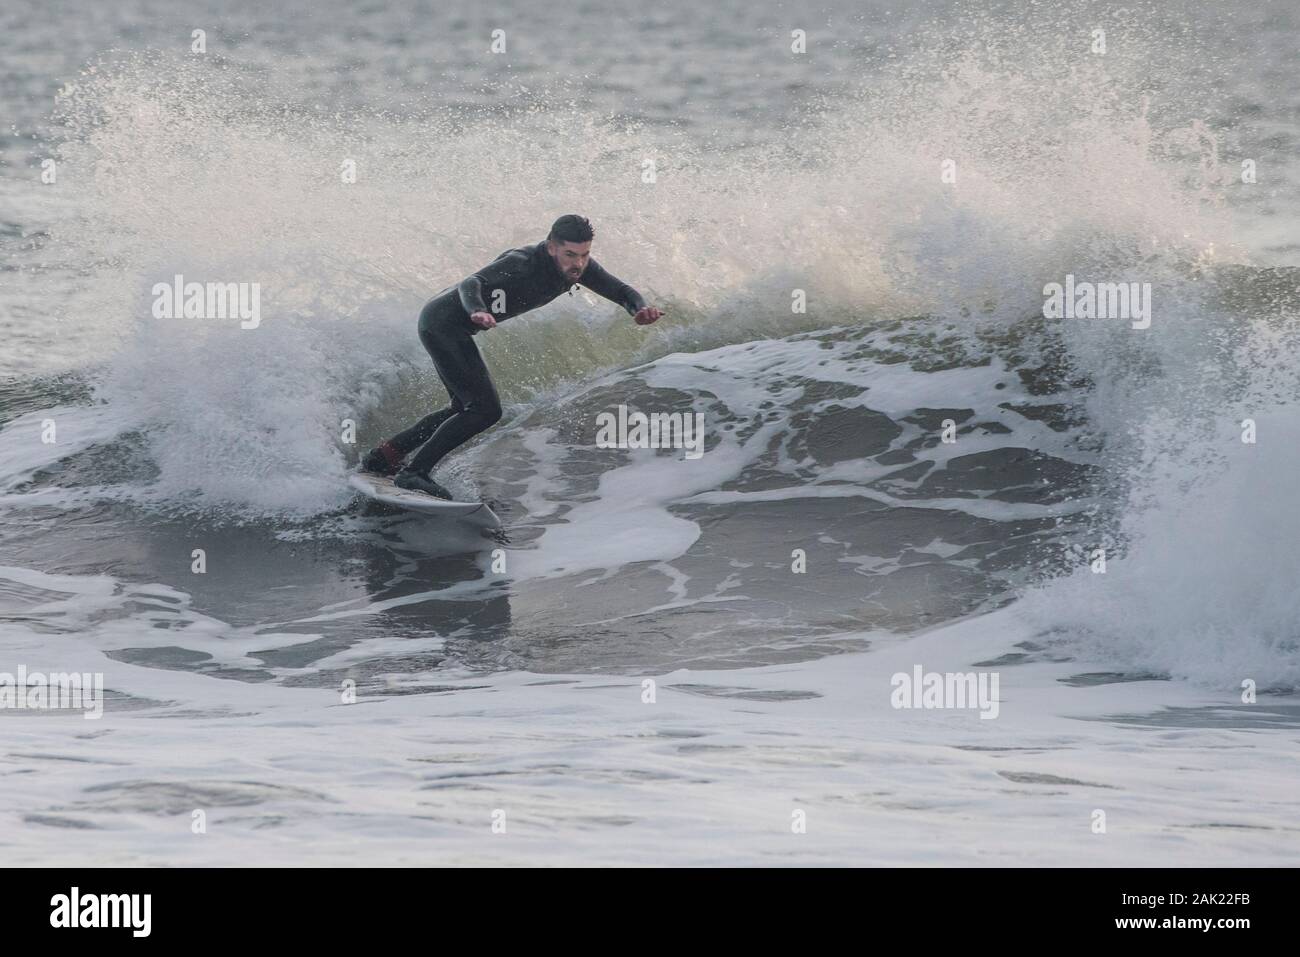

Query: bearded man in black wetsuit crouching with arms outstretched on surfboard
[361,216,663,501]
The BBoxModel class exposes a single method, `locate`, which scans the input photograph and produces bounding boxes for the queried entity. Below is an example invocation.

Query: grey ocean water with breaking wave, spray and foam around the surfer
[0,0,1300,865]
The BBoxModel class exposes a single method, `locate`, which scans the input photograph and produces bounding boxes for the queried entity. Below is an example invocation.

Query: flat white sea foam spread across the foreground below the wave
[0,582,1297,866]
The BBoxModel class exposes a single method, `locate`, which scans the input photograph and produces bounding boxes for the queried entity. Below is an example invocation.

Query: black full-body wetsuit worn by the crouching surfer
[386,241,645,476]
